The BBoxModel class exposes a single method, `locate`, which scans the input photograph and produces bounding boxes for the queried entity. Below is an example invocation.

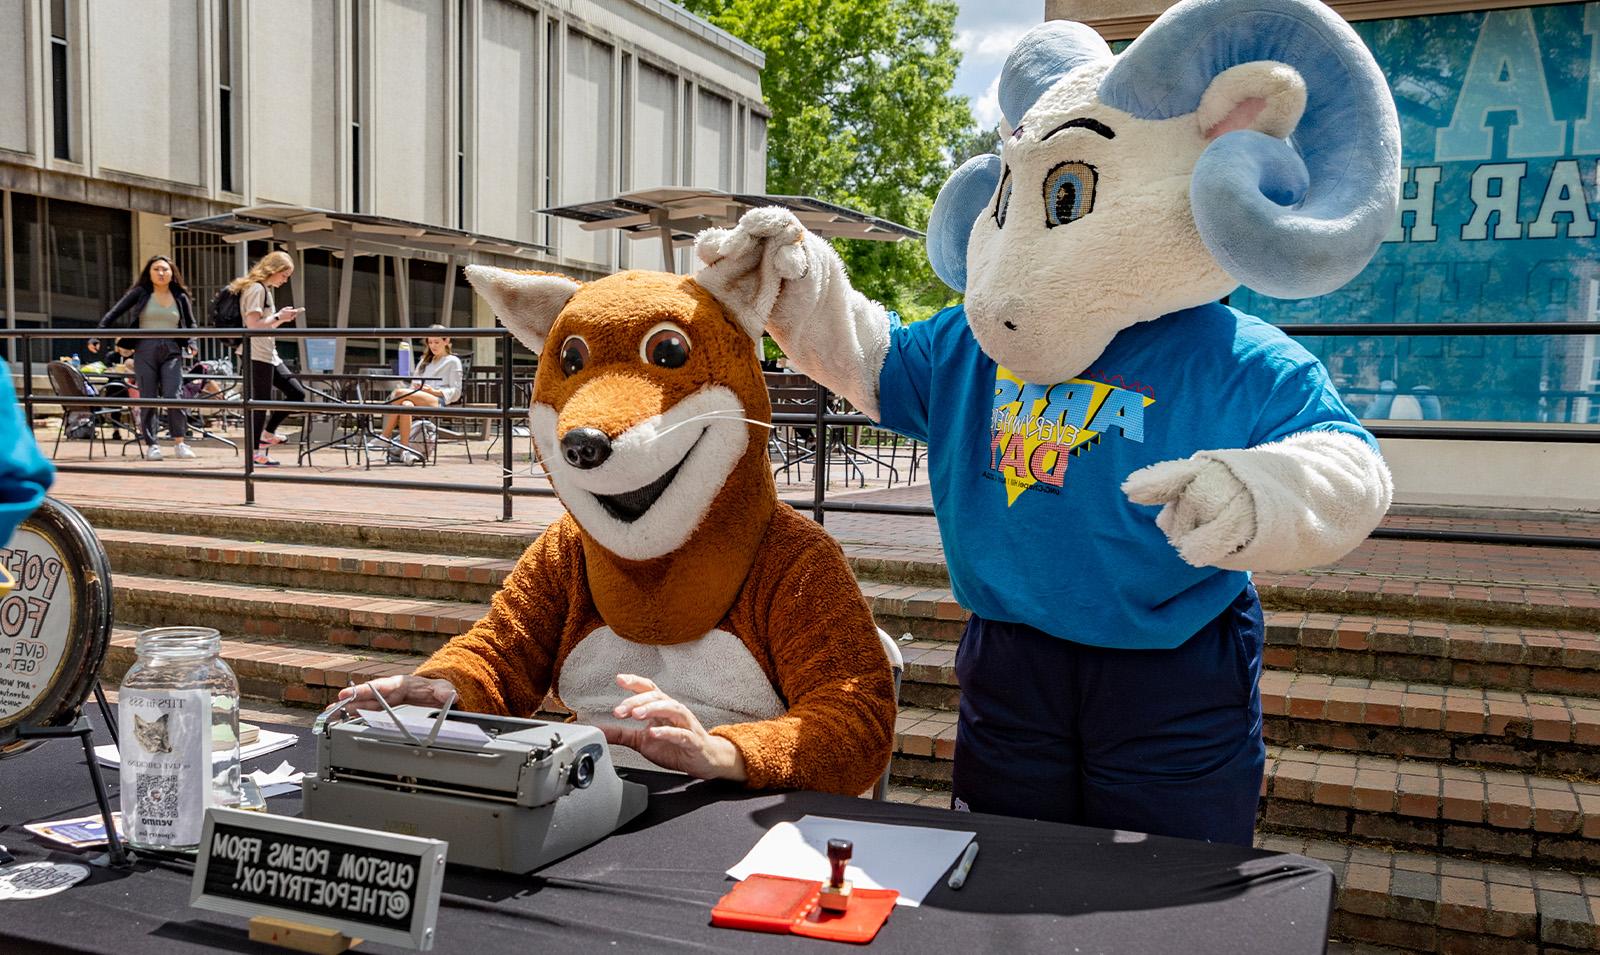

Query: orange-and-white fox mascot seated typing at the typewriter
[346,266,896,795]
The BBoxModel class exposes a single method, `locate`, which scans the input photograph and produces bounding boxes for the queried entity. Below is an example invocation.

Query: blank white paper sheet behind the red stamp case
[728,816,976,905]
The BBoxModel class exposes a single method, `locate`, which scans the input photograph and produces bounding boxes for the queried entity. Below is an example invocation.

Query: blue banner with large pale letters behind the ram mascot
[1230,3,1600,421]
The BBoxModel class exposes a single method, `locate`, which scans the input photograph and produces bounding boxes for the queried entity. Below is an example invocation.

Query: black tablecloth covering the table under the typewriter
[0,728,1333,955]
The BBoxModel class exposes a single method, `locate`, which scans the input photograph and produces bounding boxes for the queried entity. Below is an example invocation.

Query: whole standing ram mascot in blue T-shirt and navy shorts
[698,0,1400,845]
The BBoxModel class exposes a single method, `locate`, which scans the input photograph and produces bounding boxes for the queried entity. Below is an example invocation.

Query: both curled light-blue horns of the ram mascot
[928,0,1400,299]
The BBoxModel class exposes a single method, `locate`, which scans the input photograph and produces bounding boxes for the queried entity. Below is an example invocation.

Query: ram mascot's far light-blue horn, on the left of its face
[928,19,1110,291]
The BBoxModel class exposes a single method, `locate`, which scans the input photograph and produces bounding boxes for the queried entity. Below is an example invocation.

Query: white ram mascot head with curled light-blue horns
[928,0,1400,382]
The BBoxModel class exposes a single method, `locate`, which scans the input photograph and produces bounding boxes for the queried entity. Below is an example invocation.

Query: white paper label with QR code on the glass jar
[117,688,211,846]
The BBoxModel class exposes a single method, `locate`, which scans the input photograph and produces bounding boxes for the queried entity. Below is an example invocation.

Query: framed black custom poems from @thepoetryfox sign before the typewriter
[189,809,446,952]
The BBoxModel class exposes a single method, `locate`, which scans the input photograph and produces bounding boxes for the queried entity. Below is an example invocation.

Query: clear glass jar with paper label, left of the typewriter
[117,627,242,849]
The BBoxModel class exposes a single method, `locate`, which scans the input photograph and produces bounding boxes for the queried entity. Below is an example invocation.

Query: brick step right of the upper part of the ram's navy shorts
[1264,611,1600,697]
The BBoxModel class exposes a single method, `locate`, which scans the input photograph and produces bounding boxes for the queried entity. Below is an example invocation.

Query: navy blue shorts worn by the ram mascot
[954,584,1266,846]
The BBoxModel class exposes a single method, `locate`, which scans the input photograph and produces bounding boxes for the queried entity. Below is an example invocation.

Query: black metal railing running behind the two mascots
[8,322,1600,550]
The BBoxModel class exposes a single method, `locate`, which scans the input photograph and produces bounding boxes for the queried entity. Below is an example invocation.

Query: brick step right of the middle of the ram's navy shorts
[1261,670,1600,781]
